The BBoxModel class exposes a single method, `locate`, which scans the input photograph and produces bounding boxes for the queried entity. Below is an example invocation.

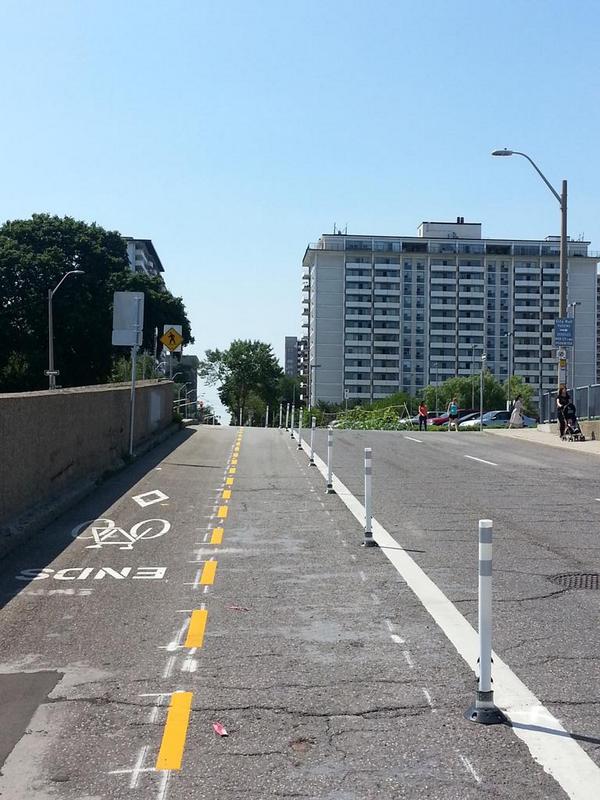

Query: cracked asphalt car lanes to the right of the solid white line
[308,424,600,776]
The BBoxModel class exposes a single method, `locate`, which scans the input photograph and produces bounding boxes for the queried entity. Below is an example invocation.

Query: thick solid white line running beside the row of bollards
[296,432,600,800]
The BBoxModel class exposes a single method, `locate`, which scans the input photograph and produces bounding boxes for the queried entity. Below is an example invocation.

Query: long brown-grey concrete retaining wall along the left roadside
[0,381,173,525]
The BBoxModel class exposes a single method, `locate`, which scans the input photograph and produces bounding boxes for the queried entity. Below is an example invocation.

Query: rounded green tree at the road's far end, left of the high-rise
[199,339,282,423]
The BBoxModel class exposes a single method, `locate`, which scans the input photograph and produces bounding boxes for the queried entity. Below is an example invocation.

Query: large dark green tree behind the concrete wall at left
[0,214,193,391]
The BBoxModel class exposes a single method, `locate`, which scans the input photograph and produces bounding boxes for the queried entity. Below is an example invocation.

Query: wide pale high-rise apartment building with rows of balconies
[303,217,599,404]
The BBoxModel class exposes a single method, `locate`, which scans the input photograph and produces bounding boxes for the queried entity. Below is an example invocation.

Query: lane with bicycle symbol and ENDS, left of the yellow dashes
[0,428,241,800]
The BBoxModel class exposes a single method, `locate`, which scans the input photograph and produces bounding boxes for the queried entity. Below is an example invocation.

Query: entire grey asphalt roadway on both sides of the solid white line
[0,427,600,800]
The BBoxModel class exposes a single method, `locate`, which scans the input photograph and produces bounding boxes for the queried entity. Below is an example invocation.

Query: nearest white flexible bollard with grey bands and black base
[465,519,508,725]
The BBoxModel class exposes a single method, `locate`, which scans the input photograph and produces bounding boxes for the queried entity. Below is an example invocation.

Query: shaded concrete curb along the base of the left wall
[0,423,181,557]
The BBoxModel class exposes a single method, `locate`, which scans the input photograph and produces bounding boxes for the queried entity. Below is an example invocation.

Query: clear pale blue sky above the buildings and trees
[0,0,600,418]
